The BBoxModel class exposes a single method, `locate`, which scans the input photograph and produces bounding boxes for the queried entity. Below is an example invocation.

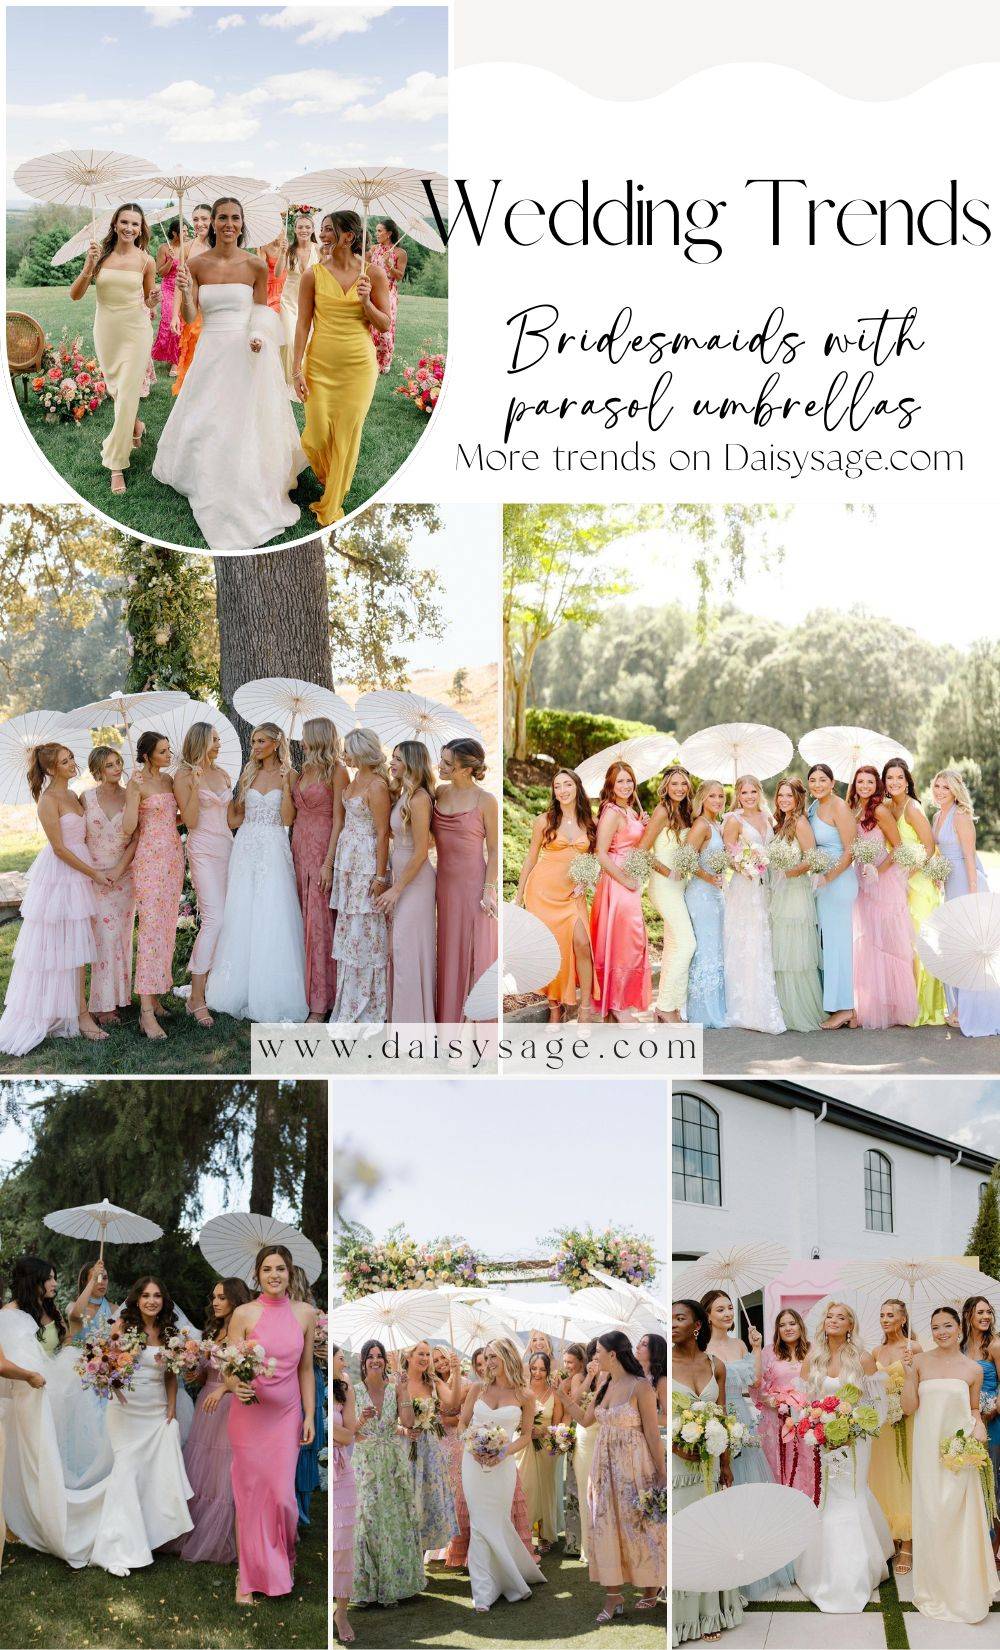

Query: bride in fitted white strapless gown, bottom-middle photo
[459,1340,545,1612]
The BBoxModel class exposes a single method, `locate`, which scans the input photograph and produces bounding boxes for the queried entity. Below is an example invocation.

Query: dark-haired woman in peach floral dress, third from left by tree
[122,731,185,1041]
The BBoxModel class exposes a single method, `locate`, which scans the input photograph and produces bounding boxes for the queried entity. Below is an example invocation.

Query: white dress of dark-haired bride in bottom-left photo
[91,1346,195,1576]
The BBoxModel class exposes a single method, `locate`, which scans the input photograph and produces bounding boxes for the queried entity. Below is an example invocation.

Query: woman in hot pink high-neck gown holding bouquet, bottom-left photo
[224,1244,315,1604]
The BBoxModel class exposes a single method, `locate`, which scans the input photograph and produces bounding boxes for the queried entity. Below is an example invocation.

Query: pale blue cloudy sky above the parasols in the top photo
[7,5,447,203]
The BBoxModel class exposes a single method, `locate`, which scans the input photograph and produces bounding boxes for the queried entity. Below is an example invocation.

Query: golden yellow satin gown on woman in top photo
[302,264,378,526]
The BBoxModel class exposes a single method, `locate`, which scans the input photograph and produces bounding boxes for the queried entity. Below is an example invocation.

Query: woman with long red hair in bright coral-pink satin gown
[591,762,653,1020]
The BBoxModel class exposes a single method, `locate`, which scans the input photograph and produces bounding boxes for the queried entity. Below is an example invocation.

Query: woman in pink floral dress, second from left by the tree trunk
[81,744,135,1026]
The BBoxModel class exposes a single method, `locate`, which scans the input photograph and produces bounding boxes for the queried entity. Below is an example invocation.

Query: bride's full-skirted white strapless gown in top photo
[153,282,309,551]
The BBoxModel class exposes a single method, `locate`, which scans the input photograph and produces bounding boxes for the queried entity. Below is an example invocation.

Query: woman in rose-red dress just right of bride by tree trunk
[292,716,350,1023]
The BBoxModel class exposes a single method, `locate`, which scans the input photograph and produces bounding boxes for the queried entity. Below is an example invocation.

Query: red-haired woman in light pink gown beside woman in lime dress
[847,767,917,1031]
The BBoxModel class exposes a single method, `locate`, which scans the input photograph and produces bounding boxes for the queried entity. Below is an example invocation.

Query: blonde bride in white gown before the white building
[795,1300,893,1615]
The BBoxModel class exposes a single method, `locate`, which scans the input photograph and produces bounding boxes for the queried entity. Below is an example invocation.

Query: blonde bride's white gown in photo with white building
[795,1376,893,1615]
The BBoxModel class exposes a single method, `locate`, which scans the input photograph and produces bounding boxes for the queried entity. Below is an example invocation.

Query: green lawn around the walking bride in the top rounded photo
[7,285,447,549]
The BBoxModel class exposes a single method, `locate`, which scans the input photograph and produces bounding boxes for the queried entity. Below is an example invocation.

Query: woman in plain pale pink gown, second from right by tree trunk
[376,739,437,1025]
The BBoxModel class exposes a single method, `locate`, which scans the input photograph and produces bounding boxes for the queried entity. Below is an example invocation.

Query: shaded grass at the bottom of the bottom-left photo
[0,1497,327,1650]
